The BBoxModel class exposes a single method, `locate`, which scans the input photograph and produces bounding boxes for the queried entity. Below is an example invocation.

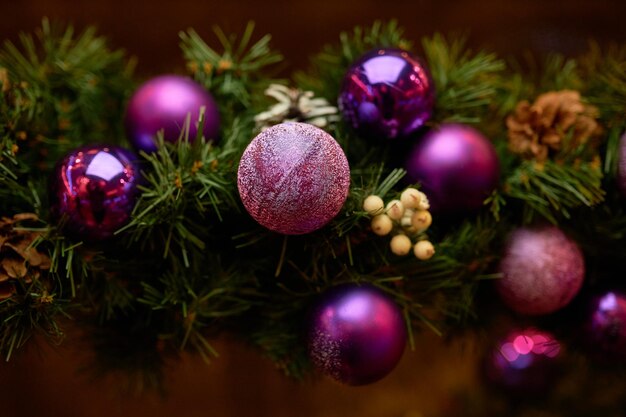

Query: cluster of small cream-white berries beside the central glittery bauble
[363,188,435,260]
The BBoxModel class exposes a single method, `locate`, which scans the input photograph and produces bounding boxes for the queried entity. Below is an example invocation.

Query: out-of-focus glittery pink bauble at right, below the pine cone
[495,226,585,315]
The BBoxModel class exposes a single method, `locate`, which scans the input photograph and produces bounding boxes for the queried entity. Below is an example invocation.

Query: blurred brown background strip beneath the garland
[0,328,477,417]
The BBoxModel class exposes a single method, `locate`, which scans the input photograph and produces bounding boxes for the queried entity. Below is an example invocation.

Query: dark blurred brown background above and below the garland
[0,0,626,417]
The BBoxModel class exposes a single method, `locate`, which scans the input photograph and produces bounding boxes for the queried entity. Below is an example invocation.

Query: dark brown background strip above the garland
[0,0,626,74]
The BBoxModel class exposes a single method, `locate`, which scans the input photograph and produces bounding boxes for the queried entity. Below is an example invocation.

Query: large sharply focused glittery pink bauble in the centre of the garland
[237,123,350,235]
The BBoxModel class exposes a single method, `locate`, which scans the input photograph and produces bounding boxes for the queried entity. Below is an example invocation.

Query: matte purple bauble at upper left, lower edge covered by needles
[125,75,220,152]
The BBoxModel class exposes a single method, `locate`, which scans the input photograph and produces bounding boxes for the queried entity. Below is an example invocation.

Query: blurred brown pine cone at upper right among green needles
[506,90,602,162]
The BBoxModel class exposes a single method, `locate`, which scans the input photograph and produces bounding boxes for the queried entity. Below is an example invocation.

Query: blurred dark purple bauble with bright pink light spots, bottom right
[484,328,561,396]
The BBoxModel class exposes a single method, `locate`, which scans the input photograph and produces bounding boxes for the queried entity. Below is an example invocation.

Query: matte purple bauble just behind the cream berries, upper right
[405,124,500,212]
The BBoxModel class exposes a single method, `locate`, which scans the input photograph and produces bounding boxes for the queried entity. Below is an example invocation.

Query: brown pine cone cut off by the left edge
[0,213,50,301]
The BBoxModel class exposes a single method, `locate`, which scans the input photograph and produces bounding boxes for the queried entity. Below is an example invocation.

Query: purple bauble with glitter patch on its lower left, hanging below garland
[307,284,407,385]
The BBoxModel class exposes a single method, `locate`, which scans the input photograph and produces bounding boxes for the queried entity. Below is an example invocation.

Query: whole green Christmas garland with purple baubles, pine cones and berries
[0,20,626,396]
